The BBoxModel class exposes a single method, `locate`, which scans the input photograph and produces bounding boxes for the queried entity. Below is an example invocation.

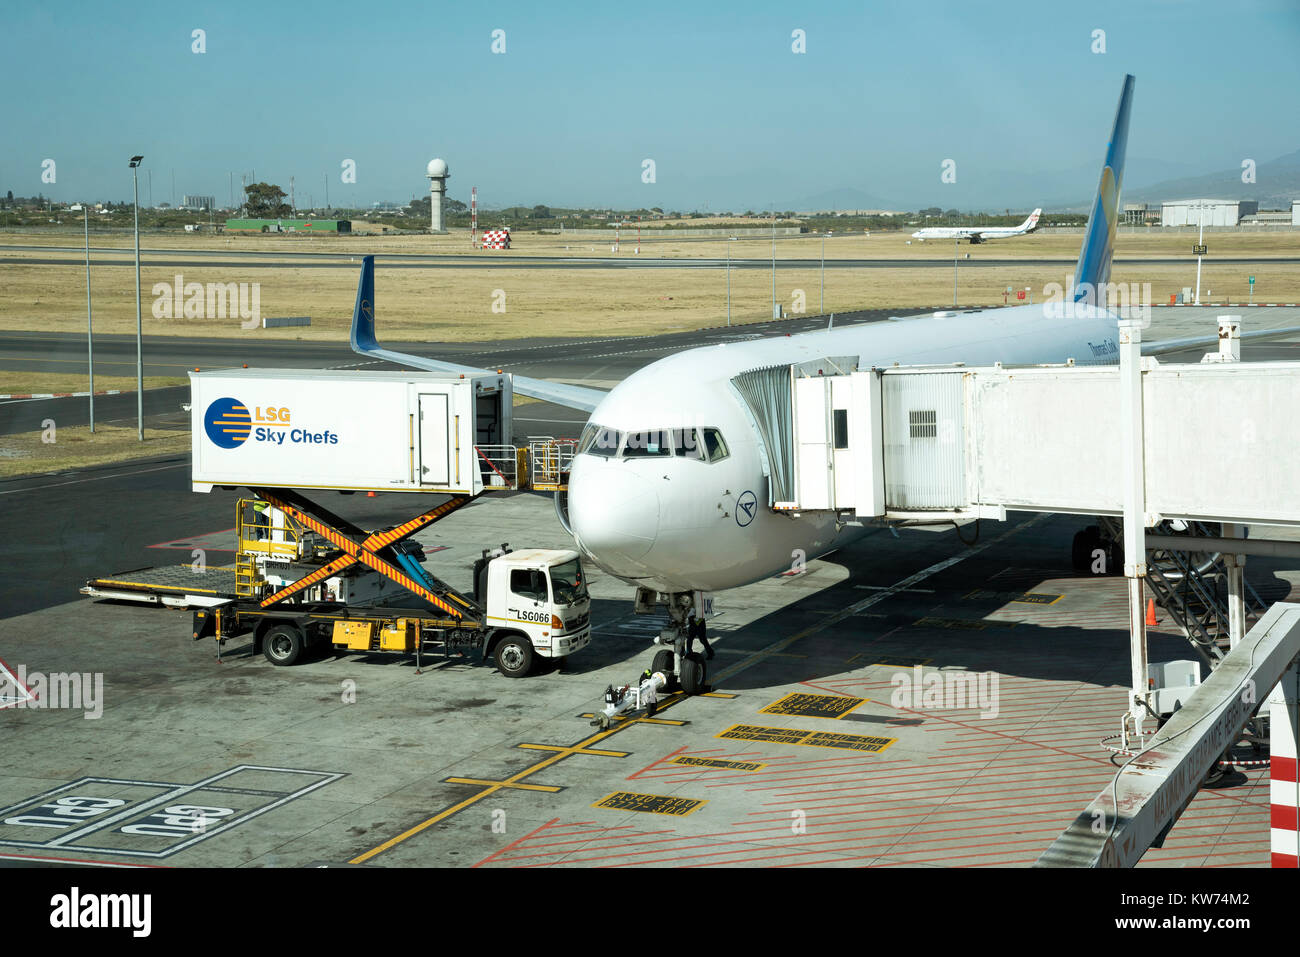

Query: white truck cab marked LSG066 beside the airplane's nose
[475,545,592,677]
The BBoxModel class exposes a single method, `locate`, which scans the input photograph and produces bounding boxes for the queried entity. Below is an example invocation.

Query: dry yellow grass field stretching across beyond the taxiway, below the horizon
[0,231,1300,343]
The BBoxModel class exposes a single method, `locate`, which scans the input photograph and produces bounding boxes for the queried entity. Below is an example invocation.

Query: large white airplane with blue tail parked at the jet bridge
[352,77,1289,686]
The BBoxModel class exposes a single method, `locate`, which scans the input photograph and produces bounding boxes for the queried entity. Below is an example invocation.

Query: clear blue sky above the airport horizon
[0,0,1300,211]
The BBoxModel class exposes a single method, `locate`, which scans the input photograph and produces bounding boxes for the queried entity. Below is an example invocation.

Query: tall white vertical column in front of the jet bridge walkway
[1119,320,1149,745]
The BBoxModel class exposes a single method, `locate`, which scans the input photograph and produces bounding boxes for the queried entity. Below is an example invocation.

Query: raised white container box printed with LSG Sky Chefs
[190,369,512,495]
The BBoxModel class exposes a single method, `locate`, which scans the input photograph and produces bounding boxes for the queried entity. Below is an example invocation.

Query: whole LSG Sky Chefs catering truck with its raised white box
[82,369,590,677]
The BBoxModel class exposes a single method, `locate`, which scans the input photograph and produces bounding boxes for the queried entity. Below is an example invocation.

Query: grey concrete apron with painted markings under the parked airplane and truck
[0,309,1300,867]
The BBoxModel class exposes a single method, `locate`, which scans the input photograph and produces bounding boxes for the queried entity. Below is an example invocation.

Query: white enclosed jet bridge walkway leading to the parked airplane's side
[767,327,1300,525]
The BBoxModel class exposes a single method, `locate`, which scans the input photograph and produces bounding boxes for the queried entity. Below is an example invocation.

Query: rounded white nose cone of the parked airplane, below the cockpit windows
[568,460,659,566]
